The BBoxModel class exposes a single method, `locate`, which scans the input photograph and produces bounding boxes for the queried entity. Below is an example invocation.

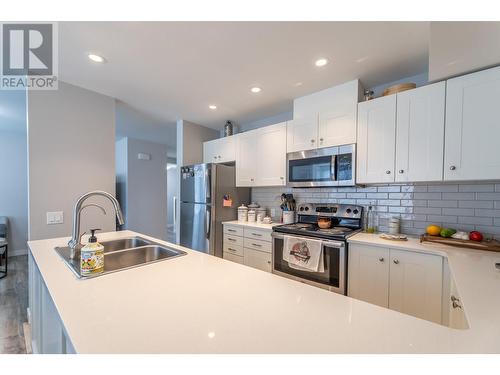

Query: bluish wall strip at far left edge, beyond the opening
[0,91,28,255]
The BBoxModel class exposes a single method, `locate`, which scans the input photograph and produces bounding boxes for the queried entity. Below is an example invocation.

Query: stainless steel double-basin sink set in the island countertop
[55,237,186,279]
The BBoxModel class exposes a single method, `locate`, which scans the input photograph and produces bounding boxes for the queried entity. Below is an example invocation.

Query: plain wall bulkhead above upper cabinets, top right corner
[429,22,500,81]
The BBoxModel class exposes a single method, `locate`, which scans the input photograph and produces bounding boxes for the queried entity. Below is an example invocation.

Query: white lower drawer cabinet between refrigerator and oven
[223,224,272,272]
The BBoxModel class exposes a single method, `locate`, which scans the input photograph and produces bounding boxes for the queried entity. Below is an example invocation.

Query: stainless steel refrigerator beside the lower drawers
[179,164,250,258]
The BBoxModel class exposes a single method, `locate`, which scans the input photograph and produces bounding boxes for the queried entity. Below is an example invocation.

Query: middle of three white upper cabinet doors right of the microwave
[395,82,446,182]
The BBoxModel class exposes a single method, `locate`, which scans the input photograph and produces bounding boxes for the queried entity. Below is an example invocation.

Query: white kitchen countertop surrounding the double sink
[29,231,500,353]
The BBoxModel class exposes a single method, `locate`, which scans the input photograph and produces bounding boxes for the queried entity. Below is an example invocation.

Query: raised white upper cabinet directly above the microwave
[287,80,362,152]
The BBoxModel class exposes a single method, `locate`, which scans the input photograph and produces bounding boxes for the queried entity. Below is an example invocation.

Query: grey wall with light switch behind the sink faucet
[27,82,116,240]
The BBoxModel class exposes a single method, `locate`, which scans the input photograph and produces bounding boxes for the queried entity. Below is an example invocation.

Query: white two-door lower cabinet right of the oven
[348,244,443,323]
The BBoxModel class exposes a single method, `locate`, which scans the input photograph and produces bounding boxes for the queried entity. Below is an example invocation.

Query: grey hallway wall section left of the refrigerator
[117,138,167,239]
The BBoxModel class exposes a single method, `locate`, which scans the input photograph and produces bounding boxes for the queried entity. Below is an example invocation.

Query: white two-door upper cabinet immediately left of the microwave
[236,122,286,186]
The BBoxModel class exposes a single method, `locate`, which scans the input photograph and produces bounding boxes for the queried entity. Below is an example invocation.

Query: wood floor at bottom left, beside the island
[0,255,28,354]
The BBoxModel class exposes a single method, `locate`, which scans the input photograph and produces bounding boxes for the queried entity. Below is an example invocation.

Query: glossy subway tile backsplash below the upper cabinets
[252,182,500,239]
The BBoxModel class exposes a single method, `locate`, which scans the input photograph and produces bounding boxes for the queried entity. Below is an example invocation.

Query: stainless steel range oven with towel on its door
[272,203,363,294]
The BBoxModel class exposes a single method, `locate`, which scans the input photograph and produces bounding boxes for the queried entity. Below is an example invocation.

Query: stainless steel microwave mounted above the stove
[287,144,356,187]
